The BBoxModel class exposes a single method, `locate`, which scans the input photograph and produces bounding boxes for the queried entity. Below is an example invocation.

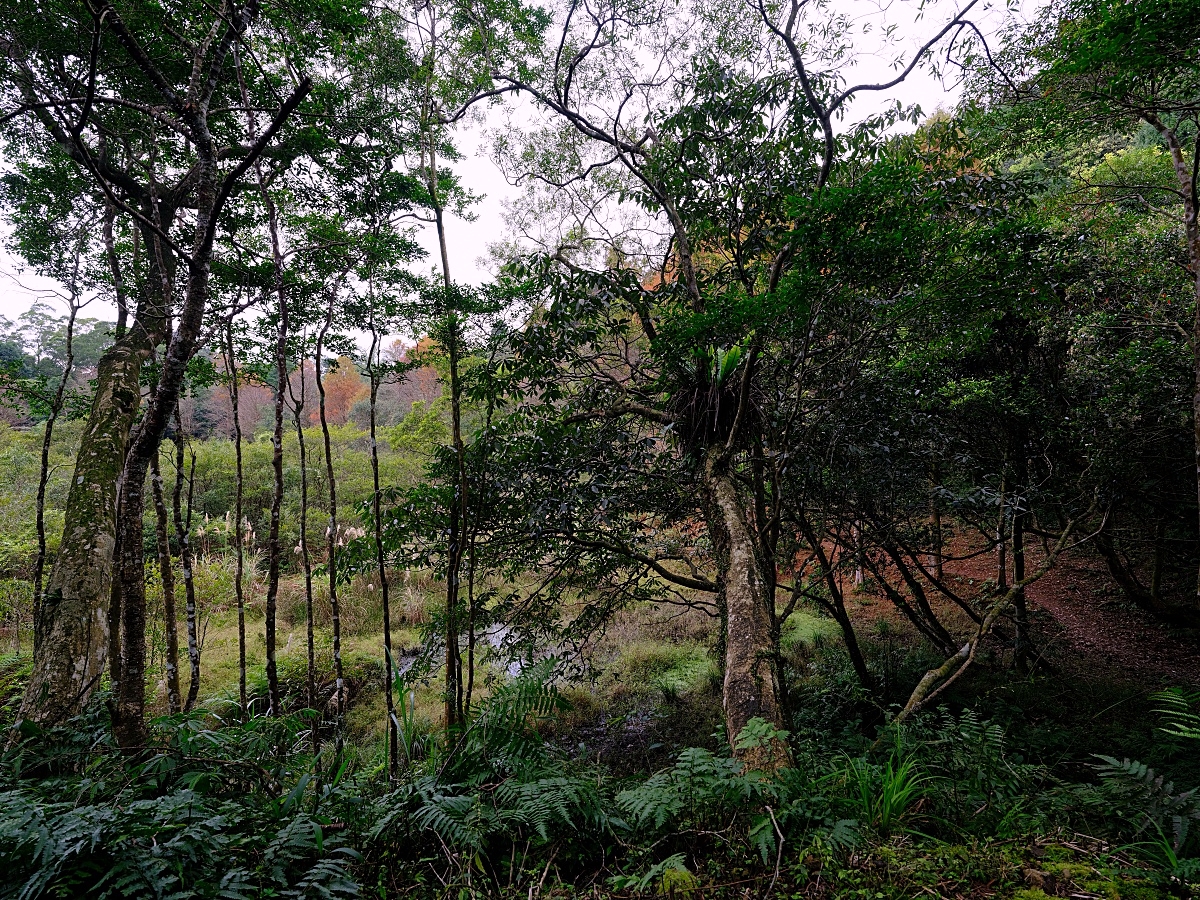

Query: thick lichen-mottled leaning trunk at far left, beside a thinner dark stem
[19,336,149,726]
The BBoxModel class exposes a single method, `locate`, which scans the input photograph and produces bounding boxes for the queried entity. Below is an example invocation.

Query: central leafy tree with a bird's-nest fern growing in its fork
[458,2,973,767]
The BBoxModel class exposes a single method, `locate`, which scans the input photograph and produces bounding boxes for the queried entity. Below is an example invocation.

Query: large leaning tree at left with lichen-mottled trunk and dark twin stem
[0,0,319,746]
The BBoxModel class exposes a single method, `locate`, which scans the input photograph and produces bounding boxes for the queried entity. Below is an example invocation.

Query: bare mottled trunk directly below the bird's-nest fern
[704,450,788,770]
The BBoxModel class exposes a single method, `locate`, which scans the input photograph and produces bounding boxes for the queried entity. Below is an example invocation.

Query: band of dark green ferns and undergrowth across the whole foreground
[0,668,1200,900]
